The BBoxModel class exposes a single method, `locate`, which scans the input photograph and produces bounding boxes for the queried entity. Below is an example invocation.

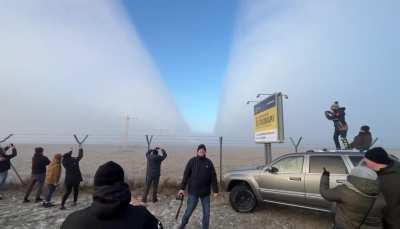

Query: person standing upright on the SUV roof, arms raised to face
[325,101,348,150]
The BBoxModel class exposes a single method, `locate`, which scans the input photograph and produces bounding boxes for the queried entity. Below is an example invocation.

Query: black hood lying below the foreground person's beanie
[90,182,131,219]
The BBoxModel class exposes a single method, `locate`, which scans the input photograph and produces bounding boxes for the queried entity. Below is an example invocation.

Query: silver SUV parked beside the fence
[224,150,363,212]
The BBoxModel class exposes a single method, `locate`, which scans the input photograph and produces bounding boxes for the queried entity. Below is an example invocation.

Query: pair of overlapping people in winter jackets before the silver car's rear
[320,147,400,229]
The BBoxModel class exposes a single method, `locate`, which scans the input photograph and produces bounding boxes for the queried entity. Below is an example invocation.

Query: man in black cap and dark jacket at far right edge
[364,147,400,229]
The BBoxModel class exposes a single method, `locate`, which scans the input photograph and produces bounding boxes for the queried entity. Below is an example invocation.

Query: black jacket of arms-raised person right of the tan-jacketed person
[62,149,83,185]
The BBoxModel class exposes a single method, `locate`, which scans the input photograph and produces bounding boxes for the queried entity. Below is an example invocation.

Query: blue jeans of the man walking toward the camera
[180,194,210,229]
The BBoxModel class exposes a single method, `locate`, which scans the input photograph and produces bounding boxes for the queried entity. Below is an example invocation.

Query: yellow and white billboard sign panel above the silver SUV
[254,93,285,143]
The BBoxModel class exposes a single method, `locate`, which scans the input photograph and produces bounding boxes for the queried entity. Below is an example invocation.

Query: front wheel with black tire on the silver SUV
[229,184,257,213]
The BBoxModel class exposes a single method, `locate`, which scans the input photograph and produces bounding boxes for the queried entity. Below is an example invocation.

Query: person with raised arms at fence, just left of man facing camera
[142,147,167,203]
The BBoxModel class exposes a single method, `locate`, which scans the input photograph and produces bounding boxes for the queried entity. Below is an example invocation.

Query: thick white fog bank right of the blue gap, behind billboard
[216,0,400,147]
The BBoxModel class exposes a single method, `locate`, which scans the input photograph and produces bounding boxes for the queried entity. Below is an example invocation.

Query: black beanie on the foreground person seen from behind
[94,161,124,186]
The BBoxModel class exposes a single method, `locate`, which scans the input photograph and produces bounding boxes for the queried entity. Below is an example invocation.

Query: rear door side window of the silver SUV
[310,156,347,174]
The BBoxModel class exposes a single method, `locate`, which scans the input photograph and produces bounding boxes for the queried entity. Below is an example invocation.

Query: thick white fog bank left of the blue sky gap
[0,0,187,142]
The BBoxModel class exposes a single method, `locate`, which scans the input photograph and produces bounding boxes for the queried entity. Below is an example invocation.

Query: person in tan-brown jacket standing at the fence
[42,153,61,207]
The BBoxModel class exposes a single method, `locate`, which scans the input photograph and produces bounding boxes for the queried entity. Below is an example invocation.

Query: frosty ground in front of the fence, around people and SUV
[0,191,332,229]
